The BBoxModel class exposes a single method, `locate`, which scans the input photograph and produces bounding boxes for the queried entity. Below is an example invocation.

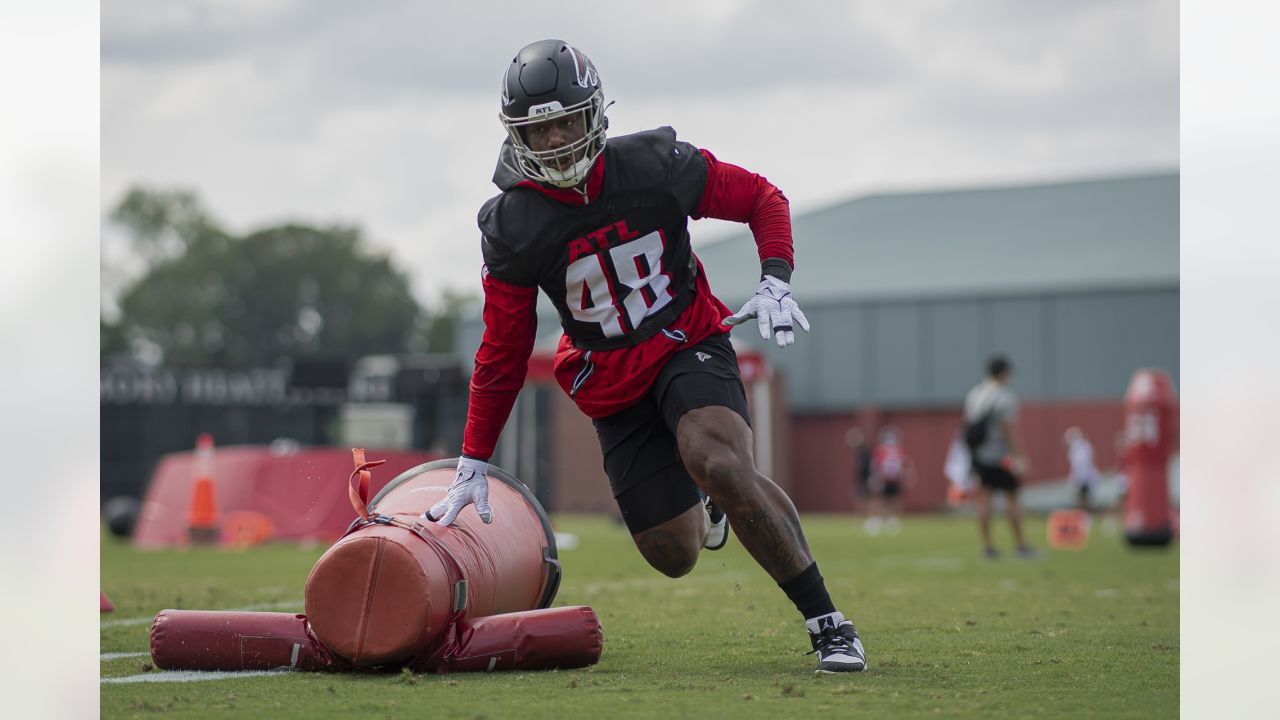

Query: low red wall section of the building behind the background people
[791,400,1141,512]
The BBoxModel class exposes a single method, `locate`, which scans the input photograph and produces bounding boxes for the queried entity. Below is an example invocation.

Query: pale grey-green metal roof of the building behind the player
[694,172,1179,302]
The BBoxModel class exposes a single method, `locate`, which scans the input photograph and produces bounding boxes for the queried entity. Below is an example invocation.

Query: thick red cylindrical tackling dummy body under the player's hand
[306,454,559,667]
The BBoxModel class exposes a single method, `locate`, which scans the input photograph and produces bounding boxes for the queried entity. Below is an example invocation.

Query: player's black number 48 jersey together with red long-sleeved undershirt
[462,127,792,459]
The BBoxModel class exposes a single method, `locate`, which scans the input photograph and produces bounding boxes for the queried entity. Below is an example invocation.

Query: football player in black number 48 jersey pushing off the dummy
[425,40,867,673]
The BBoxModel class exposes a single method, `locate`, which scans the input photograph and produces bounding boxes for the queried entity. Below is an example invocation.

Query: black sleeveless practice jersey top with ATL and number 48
[479,129,707,350]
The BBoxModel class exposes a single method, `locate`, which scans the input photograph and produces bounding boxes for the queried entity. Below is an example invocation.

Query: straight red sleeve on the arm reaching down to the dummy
[462,272,538,460]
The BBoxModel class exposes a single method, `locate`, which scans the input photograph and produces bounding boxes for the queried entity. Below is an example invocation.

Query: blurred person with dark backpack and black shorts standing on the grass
[964,355,1038,559]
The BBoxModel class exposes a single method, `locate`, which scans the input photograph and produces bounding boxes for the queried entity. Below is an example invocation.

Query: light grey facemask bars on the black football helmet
[498,90,607,188]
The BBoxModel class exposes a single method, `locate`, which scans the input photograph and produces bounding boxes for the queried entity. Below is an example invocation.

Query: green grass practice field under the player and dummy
[101,515,1179,720]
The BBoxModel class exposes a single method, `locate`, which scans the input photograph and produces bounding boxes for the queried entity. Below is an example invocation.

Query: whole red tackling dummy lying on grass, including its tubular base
[151,451,603,673]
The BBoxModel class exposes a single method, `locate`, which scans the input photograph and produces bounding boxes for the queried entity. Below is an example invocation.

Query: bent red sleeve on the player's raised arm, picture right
[694,150,795,282]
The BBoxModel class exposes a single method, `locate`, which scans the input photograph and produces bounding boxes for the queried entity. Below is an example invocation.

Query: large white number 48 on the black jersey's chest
[564,231,672,337]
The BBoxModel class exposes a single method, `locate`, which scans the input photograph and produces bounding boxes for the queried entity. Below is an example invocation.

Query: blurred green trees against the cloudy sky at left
[100,187,479,368]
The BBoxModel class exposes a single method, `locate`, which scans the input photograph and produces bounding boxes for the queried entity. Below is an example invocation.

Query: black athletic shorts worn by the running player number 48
[593,333,751,534]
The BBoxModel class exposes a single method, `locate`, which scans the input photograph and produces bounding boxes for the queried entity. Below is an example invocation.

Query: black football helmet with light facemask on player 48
[498,40,608,187]
